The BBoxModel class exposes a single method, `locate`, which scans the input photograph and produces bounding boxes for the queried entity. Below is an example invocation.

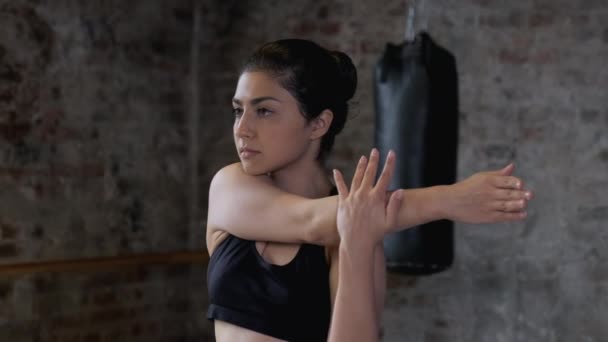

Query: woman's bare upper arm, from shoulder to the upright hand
[207,163,339,248]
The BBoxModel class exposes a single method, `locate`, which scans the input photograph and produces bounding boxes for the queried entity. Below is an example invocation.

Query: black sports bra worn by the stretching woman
[207,235,331,341]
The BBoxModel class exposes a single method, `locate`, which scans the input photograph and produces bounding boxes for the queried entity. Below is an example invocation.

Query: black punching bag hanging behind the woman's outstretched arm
[374,32,458,274]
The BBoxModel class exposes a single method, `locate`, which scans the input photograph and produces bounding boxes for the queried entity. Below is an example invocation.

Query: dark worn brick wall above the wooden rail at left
[0,1,192,261]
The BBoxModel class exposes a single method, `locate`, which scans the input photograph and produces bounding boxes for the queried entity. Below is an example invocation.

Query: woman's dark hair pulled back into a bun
[242,39,357,161]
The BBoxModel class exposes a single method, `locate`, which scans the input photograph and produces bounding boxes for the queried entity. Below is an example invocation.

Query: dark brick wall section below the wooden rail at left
[0,265,213,342]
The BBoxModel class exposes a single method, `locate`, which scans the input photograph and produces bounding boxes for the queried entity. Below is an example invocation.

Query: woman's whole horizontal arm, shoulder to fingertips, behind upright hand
[207,151,531,250]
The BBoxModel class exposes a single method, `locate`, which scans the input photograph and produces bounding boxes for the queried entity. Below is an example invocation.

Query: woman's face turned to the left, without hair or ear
[232,71,312,175]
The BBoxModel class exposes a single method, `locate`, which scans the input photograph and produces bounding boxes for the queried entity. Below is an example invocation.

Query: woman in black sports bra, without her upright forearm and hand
[207,39,531,342]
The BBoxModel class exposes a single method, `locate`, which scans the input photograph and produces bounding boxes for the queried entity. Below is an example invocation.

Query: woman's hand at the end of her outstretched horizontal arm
[444,163,532,223]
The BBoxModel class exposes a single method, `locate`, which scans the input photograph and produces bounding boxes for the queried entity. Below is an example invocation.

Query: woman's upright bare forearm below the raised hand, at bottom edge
[329,242,378,342]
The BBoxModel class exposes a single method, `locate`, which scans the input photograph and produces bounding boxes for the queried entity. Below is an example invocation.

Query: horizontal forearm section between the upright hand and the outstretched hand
[394,185,450,231]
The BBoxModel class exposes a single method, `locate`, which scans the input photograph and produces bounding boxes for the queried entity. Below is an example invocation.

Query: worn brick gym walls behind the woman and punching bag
[0,0,608,342]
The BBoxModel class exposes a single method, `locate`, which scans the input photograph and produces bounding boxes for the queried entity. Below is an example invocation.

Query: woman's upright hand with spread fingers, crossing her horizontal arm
[334,148,402,248]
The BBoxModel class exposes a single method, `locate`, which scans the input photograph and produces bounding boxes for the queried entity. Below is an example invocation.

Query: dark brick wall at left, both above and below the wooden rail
[0,1,211,342]
